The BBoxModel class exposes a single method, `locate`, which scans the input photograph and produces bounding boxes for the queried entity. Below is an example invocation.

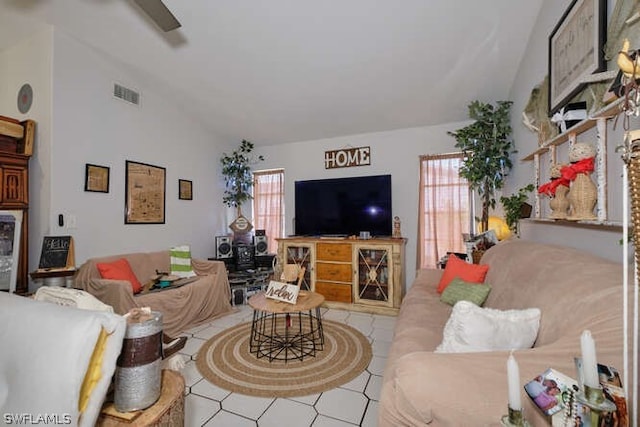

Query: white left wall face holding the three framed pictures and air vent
[47,31,231,263]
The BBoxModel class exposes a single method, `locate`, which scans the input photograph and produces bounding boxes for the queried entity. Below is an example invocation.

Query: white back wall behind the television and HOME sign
[256,122,466,286]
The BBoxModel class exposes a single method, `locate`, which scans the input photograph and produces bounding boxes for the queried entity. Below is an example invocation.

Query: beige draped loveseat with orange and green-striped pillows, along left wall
[75,251,232,337]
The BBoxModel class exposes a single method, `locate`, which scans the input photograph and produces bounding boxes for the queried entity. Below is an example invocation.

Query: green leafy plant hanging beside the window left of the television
[220,139,264,212]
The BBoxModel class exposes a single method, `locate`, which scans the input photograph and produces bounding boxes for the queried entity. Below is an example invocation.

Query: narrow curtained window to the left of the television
[253,169,284,253]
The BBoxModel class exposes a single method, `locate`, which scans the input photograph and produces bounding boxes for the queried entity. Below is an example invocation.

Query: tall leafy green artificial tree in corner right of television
[447,101,516,234]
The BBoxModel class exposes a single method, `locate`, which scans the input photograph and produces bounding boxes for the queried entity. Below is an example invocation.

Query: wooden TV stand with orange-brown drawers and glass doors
[274,237,407,315]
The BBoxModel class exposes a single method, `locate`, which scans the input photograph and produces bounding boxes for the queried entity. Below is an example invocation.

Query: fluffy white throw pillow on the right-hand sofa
[435,301,540,353]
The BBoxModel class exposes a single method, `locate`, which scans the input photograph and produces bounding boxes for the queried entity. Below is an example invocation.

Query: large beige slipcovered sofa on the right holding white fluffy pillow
[379,239,630,427]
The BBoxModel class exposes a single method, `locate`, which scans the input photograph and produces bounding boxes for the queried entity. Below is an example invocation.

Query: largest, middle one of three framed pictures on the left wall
[124,160,167,224]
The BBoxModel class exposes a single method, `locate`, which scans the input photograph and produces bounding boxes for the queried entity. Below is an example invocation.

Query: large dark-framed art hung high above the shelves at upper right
[549,0,607,116]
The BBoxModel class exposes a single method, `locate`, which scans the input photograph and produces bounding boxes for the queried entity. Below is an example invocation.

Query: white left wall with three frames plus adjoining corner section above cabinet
[0,29,234,290]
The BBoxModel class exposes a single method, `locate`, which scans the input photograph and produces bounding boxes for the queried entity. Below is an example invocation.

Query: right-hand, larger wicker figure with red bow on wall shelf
[560,143,598,221]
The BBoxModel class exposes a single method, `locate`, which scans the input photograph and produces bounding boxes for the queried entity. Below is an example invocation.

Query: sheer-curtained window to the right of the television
[417,153,472,268]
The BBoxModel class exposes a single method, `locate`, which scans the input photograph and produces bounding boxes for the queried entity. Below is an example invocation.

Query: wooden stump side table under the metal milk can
[96,369,184,427]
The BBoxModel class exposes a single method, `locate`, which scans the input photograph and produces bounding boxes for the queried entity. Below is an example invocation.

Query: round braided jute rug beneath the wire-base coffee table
[196,320,371,397]
